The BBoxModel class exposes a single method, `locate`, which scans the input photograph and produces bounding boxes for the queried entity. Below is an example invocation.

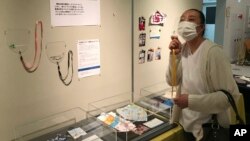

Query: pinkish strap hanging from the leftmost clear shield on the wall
[19,21,43,73]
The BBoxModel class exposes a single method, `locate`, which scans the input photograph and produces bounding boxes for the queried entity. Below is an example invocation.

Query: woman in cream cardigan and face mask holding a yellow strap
[166,9,240,141]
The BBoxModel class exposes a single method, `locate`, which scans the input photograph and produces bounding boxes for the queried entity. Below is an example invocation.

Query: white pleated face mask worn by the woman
[178,21,198,41]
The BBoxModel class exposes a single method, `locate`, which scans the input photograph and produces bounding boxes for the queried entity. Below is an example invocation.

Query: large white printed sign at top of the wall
[50,0,100,26]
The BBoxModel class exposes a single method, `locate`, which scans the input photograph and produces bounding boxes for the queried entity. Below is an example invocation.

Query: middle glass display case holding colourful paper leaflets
[88,93,177,141]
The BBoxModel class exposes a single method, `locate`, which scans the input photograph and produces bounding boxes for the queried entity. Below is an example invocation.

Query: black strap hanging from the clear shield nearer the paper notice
[57,50,73,86]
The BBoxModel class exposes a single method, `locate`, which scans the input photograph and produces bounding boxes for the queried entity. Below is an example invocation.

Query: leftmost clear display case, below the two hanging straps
[15,108,116,141]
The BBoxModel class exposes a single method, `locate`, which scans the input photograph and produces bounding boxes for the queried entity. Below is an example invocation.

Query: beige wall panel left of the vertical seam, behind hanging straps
[0,0,132,141]
